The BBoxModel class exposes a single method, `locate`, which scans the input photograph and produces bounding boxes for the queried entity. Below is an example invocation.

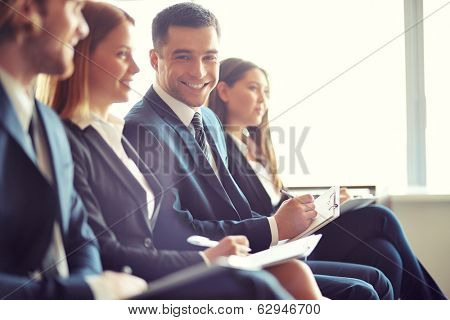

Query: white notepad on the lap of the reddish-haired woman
[227,234,322,270]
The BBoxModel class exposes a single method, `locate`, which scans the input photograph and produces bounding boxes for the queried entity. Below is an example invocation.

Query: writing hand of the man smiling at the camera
[274,194,317,240]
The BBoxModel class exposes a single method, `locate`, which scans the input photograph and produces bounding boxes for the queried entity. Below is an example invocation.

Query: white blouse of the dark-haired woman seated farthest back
[228,134,281,207]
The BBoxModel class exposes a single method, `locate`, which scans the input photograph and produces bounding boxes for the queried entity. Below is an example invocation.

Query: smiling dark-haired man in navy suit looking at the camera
[124,3,392,299]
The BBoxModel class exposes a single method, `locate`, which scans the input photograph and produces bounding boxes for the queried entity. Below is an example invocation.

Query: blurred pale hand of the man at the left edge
[91,271,148,299]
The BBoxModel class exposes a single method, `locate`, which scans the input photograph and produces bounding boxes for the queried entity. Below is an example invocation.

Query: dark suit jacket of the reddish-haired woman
[65,122,203,281]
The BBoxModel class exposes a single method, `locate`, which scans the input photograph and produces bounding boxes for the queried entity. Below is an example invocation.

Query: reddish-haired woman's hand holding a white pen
[203,236,249,262]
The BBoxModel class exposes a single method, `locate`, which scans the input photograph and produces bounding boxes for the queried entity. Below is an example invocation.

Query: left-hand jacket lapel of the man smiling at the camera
[146,88,234,207]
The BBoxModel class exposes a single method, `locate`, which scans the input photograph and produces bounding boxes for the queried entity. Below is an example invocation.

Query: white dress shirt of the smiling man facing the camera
[153,82,278,246]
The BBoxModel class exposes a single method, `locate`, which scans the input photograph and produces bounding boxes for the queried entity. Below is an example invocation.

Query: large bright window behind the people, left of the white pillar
[110,0,422,191]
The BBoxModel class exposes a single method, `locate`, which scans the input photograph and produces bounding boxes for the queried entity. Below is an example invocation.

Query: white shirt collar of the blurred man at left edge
[0,68,34,131]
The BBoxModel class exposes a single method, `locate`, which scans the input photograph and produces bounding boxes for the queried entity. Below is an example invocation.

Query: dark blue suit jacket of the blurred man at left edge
[0,84,101,299]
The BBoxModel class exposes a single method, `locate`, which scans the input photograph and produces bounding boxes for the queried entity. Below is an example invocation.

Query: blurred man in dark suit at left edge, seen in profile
[0,0,147,299]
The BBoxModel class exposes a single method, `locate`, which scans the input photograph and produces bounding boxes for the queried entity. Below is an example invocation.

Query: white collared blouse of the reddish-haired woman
[72,112,155,219]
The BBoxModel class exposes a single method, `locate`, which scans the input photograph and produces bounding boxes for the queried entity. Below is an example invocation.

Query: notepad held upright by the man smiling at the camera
[289,186,340,242]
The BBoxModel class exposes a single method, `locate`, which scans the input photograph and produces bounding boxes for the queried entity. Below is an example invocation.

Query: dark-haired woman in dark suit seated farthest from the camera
[208,58,445,299]
